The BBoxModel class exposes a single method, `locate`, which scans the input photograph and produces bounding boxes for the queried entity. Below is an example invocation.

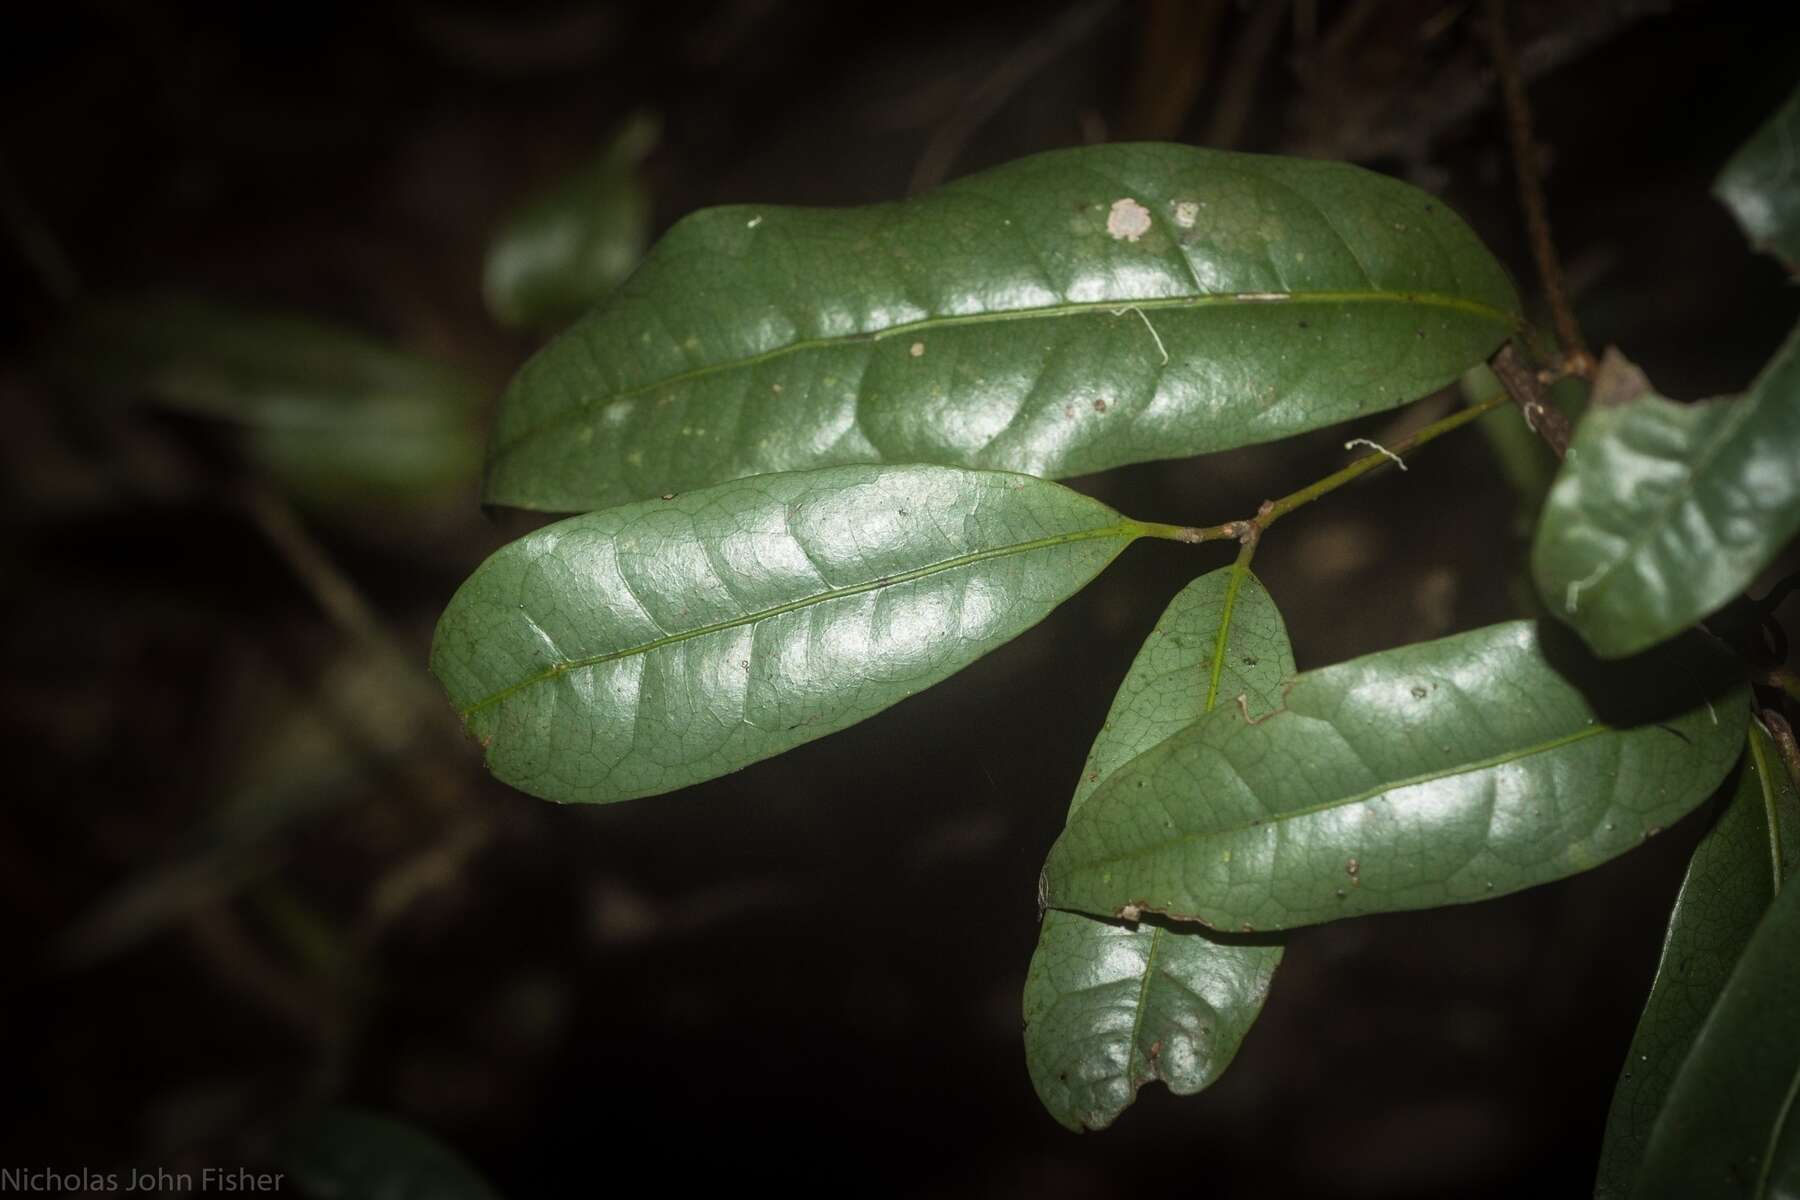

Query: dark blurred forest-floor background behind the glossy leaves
[0,0,1800,1196]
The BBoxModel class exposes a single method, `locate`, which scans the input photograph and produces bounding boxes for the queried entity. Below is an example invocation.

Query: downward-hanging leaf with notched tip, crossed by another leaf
[1024,567,1294,1130]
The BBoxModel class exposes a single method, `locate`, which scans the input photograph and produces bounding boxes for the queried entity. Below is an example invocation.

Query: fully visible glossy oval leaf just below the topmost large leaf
[432,466,1181,802]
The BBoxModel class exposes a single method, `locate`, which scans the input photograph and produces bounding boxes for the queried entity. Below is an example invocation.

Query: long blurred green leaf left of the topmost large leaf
[49,293,481,504]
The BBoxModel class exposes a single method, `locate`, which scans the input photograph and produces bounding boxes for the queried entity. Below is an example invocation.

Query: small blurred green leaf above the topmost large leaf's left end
[482,113,662,326]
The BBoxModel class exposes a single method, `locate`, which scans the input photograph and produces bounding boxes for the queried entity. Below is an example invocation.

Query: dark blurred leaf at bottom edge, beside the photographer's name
[275,1108,500,1200]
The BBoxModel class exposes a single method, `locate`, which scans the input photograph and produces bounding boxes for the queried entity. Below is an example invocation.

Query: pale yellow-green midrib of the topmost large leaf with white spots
[490,291,1519,461]
